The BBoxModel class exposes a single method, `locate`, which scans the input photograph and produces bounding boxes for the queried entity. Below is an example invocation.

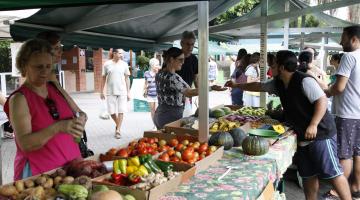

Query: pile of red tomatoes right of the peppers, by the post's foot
[159,139,217,164]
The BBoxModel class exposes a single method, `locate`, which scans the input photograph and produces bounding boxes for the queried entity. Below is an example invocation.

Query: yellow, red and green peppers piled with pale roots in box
[105,154,180,190]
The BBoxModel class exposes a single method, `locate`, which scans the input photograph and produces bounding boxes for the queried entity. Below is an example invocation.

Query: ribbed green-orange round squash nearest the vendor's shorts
[242,136,270,156]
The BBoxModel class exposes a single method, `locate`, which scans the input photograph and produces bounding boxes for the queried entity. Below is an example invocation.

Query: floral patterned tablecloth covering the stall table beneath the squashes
[161,134,296,200]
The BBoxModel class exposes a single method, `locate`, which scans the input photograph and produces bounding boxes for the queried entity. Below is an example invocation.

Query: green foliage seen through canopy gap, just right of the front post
[210,0,260,26]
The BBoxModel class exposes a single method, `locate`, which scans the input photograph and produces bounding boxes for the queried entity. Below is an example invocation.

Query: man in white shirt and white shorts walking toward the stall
[100,49,130,139]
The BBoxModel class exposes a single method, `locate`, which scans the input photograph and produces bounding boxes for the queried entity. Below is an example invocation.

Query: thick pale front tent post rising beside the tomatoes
[198,1,209,142]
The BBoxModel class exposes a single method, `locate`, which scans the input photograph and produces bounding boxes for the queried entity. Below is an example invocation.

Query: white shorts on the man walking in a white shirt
[106,95,127,115]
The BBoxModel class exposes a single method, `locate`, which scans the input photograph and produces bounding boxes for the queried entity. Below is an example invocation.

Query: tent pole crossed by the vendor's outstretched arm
[260,0,268,107]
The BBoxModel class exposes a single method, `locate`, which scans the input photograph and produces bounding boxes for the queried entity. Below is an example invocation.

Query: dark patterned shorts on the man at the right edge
[335,117,360,159]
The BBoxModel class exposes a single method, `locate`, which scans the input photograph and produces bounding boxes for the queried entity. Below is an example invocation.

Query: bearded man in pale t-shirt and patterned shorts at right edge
[325,25,360,198]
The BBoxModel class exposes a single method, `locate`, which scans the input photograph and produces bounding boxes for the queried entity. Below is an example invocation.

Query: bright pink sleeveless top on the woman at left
[4,84,81,180]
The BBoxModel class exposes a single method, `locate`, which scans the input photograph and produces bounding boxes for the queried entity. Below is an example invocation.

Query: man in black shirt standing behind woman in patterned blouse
[176,31,198,88]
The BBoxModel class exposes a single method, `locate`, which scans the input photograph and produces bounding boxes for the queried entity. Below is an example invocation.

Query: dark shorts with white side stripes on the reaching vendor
[295,136,343,179]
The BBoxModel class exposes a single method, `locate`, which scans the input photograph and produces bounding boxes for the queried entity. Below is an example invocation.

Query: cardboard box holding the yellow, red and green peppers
[93,163,195,200]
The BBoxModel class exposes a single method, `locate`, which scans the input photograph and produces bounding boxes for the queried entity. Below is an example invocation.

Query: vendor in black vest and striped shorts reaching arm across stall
[225,51,351,200]
